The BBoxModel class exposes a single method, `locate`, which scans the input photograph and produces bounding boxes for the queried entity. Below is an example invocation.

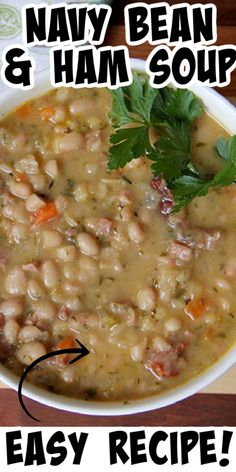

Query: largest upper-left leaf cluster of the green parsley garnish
[108,73,203,174]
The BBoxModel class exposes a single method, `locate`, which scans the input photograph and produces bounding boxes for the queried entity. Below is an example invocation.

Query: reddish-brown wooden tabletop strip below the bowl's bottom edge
[0,390,236,427]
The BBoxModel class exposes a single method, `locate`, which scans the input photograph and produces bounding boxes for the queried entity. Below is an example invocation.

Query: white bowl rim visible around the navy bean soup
[0,59,236,416]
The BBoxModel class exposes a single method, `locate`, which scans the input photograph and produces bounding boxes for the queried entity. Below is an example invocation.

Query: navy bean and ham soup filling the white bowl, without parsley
[0,89,236,401]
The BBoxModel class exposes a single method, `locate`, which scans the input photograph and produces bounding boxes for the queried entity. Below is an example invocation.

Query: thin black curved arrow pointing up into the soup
[18,339,89,423]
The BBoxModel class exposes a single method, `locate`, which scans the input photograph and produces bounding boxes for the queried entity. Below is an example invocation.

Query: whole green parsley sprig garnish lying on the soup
[108,73,236,211]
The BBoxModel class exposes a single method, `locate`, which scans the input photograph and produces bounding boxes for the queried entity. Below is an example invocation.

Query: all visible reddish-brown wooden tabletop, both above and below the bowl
[0,0,236,426]
